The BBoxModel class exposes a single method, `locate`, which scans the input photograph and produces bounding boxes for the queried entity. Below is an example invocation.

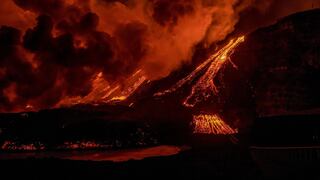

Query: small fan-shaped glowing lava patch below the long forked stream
[192,115,238,135]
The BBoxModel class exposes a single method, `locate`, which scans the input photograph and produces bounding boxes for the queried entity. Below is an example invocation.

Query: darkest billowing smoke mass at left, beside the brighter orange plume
[0,3,144,111]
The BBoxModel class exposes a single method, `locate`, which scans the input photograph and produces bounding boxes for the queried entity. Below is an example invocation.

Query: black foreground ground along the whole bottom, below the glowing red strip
[0,145,320,180]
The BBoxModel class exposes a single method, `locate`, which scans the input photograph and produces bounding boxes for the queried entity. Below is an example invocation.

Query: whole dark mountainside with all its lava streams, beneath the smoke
[0,9,320,152]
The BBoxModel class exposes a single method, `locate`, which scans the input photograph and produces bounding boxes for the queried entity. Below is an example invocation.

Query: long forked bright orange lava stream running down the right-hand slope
[154,36,245,107]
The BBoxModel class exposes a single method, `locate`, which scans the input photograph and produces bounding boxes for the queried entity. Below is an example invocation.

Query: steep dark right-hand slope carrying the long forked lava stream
[129,9,319,128]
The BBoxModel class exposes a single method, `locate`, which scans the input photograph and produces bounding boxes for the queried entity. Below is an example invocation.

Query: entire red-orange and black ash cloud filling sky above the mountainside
[0,0,319,112]
